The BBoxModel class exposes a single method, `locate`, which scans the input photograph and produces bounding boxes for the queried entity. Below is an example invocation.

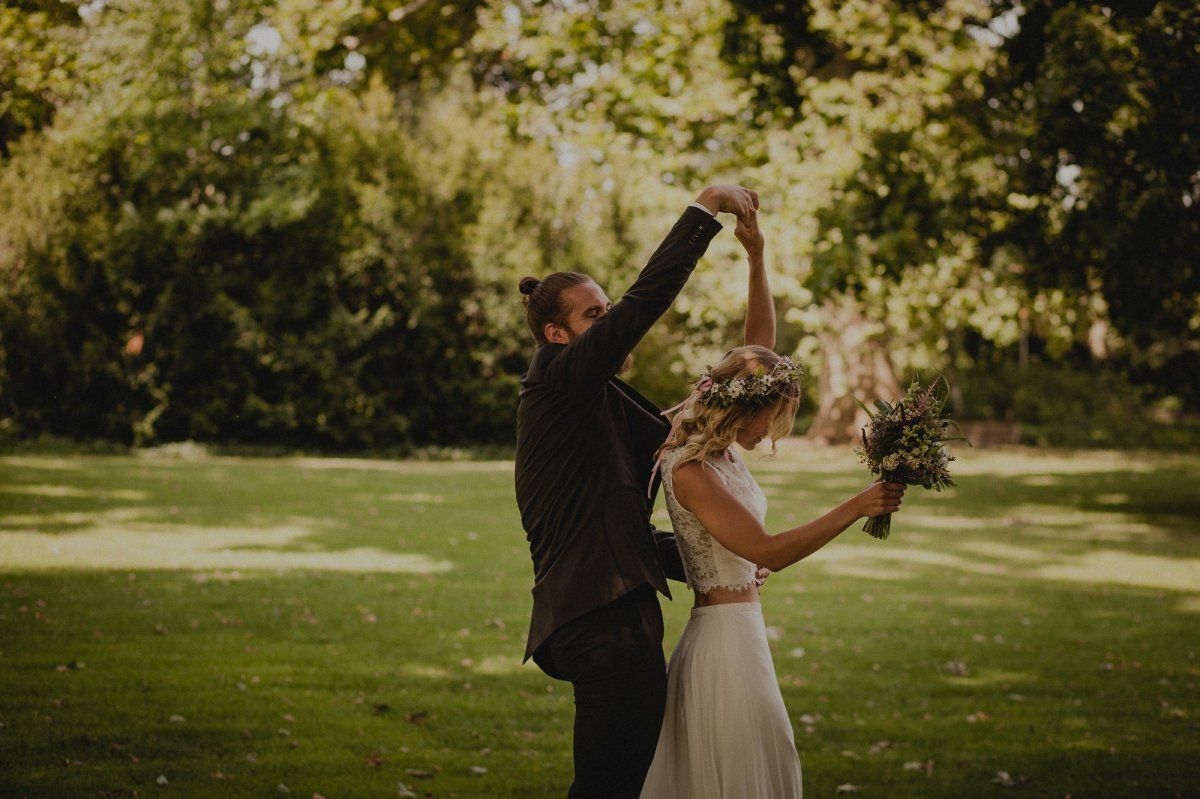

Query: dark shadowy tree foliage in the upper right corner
[989,0,1200,408]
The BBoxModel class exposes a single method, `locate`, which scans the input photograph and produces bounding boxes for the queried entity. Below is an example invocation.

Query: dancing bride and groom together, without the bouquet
[516,186,904,799]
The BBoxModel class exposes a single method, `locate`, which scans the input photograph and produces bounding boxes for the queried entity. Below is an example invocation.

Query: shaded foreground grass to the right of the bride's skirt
[764,563,1200,797]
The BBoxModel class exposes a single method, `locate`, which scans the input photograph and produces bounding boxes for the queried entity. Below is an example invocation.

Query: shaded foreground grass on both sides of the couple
[0,551,1200,798]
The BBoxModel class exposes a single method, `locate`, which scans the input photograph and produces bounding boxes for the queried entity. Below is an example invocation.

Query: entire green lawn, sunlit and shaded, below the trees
[0,443,1200,799]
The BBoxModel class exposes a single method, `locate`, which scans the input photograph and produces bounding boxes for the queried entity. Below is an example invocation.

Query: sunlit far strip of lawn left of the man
[0,458,520,572]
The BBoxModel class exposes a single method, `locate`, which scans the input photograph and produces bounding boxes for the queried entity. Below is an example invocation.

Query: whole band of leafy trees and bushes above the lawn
[0,0,1200,449]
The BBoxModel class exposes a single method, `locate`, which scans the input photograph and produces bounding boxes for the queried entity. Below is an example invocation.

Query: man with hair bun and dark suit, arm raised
[516,186,758,799]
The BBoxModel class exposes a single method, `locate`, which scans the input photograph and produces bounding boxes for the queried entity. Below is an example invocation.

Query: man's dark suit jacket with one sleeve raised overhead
[516,206,721,660]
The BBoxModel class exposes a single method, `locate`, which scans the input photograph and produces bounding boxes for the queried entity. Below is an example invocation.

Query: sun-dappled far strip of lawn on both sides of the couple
[7,450,1200,599]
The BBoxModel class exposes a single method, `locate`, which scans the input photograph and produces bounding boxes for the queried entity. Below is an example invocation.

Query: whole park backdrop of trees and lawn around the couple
[0,0,1200,797]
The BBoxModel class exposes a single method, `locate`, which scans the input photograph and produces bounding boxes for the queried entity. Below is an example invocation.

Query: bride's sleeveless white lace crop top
[662,450,767,594]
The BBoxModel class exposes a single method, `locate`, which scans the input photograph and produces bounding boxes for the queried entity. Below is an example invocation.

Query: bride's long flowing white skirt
[642,602,800,799]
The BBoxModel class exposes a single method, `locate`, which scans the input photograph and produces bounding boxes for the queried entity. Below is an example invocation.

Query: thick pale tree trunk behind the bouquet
[808,300,902,444]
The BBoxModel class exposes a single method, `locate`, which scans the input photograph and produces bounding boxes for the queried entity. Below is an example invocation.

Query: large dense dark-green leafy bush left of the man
[0,0,510,447]
